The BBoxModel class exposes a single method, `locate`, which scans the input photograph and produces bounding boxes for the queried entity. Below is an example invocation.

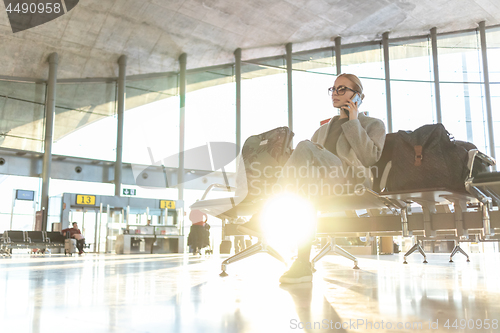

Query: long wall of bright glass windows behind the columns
[0,27,500,233]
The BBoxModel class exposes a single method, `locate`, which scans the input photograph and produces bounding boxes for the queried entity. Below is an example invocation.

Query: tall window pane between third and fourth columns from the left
[184,66,239,172]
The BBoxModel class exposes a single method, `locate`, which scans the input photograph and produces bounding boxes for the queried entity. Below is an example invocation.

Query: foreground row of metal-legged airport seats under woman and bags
[190,143,500,276]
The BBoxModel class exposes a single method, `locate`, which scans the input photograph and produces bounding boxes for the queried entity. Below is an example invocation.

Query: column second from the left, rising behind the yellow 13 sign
[115,55,127,197]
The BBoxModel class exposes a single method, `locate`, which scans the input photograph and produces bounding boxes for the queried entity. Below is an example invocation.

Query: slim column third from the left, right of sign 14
[177,53,187,200]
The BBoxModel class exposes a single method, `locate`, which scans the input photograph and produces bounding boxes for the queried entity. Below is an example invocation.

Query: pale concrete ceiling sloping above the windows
[0,0,500,79]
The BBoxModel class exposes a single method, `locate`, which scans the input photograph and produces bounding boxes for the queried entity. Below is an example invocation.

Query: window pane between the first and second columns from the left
[52,82,117,161]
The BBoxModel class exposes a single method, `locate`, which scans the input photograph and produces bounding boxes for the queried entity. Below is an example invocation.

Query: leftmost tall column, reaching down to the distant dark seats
[41,53,59,231]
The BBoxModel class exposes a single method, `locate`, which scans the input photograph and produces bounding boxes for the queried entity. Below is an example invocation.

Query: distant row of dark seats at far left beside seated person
[0,230,66,256]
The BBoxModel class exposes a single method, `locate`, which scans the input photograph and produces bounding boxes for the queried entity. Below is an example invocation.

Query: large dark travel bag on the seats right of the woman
[386,123,475,192]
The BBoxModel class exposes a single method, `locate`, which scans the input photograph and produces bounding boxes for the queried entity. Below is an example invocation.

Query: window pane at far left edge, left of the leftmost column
[0,81,46,152]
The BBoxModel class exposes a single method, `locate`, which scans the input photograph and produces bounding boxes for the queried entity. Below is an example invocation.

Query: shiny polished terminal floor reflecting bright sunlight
[0,250,500,333]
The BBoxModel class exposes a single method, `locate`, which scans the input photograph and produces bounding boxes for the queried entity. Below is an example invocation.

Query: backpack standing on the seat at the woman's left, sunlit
[236,127,294,199]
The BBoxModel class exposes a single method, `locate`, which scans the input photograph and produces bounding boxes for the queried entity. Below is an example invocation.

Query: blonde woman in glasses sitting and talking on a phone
[238,74,385,283]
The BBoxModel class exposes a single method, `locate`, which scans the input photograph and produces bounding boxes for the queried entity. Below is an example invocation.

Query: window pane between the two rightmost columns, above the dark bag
[437,32,489,152]
